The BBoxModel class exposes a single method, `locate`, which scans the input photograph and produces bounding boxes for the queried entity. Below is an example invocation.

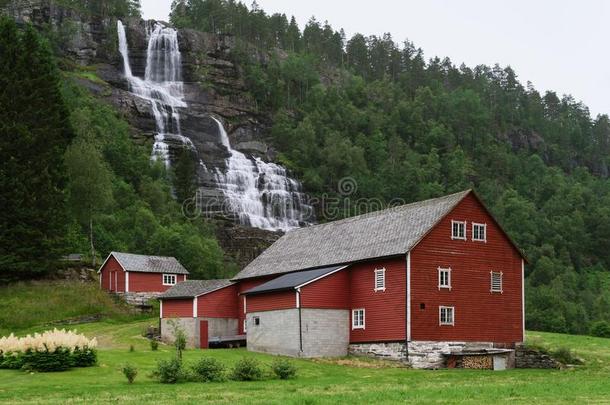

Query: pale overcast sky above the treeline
[142,0,610,115]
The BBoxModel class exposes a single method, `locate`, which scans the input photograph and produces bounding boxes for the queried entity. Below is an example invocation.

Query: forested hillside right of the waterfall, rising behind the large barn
[171,0,610,333]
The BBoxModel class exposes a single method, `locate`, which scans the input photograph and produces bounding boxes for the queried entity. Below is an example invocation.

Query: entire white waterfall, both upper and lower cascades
[117,21,313,231]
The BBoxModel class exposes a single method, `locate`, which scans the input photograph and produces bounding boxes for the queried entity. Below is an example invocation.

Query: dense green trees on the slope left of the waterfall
[0,8,236,282]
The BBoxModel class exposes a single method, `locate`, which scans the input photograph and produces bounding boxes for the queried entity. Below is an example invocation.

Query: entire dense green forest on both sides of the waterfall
[0,0,610,334]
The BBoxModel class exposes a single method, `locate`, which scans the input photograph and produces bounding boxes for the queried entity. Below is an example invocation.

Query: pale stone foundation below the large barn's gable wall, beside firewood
[409,341,494,369]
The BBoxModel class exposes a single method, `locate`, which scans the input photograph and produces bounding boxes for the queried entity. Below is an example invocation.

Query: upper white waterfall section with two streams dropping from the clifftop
[117,20,193,167]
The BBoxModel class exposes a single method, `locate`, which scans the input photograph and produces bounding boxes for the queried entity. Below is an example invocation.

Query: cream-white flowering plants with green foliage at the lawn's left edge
[0,329,97,371]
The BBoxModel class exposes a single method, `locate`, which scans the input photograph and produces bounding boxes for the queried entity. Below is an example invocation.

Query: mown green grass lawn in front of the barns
[0,318,610,404]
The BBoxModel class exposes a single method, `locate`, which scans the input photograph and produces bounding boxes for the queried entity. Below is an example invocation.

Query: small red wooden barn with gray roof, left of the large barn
[98,252,189,293]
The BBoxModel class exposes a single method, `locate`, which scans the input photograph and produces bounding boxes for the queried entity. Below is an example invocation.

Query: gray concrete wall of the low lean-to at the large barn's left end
[161,317,238,349]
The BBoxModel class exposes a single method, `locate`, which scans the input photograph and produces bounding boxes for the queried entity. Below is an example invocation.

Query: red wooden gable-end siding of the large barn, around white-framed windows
[406,195,523,343]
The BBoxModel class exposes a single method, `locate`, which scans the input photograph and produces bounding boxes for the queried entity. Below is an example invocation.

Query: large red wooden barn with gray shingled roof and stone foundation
[156,190,525,367]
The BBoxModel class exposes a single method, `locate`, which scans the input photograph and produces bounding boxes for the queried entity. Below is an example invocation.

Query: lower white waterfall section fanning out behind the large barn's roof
[212,117,312,231]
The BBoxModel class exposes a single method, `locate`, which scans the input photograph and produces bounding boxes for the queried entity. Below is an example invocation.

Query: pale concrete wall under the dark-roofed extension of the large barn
[247,308,349,357]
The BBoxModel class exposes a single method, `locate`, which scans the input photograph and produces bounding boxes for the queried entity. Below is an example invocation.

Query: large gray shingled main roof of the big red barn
[233,190,470,280]
